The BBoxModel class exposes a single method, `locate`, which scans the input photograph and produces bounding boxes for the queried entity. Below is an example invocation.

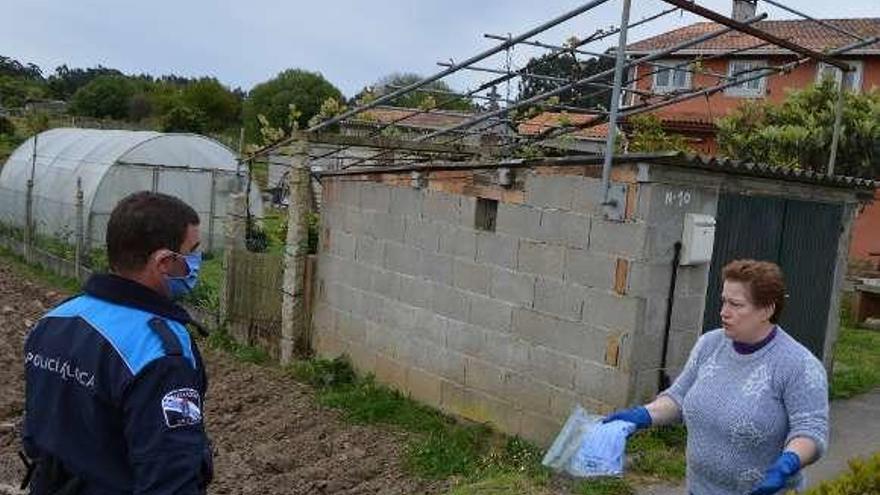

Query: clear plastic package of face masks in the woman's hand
[541,406,636,478]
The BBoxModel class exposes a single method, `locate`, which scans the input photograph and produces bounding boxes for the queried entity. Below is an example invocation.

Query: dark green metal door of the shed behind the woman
[703,194,843,359]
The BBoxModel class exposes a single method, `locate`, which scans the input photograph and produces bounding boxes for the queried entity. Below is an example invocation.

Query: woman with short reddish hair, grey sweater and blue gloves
[605,260,828,495]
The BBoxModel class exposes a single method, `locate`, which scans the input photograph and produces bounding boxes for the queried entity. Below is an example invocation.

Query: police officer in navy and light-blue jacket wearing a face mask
[23,192,212,495]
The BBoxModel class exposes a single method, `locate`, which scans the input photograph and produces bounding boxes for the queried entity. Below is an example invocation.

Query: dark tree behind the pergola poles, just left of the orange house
[519,53,614,108]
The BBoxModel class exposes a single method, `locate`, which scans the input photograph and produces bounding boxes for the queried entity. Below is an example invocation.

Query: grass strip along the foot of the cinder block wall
[290,358,672,495]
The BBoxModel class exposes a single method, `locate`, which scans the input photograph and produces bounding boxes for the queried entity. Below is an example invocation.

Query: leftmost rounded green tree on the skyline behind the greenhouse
[70,76,135,120]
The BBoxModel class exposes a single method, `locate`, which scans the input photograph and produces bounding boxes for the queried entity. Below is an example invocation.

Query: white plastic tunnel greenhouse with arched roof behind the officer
[0,129,262,250]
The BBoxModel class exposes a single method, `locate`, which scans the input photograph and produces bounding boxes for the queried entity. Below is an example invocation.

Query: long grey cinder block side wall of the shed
[313,171,659,443]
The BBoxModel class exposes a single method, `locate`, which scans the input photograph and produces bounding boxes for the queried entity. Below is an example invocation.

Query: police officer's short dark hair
[107,191,199,270]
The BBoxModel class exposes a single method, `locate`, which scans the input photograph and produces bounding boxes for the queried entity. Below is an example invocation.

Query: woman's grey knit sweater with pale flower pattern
[661,328,828,495]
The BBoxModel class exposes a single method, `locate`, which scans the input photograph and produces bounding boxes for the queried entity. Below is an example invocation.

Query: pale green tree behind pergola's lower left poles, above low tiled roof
[354,72,475,112]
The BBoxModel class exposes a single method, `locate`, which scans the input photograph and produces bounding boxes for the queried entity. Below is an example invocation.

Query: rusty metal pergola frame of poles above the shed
[251,0,878,202]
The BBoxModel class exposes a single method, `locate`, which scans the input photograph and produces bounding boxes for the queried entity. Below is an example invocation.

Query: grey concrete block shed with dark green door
[312,154,874,443]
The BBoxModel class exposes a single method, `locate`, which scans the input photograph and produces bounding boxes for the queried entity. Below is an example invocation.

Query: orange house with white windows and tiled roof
[624,12,880,154]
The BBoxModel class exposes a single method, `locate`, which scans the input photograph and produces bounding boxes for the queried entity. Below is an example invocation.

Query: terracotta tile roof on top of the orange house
[627,18,880,54]
